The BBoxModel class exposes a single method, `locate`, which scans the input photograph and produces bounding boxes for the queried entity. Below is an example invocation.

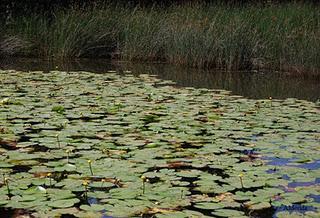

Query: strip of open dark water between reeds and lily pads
[0,58,320,101]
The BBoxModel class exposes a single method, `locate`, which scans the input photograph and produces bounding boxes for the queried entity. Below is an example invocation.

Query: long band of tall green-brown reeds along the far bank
[2,3,320,74]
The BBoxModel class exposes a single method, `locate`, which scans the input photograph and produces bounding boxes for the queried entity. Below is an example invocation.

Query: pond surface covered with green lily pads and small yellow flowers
[0,58,320,217]
